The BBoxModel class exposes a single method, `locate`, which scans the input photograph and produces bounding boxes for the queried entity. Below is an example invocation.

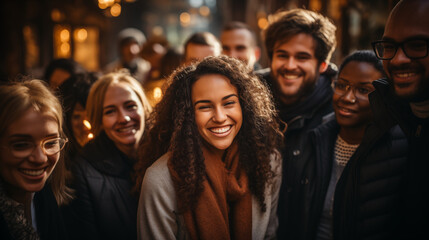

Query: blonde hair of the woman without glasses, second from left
[86,69,152,137]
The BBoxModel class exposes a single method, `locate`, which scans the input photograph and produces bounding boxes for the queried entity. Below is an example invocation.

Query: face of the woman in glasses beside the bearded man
[333,61,382,128]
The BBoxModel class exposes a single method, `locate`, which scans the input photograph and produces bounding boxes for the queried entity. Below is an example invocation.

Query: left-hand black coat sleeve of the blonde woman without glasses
[63,159,100,239]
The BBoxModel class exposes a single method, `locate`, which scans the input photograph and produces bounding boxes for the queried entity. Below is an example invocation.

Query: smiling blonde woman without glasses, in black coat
[62,71,152,240]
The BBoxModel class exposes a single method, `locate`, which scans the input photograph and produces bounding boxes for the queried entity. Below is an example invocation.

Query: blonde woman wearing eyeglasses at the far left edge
[0,80,70,240]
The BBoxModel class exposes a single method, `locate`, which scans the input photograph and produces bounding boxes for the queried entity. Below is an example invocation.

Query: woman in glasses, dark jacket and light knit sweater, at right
[280,51,384,240]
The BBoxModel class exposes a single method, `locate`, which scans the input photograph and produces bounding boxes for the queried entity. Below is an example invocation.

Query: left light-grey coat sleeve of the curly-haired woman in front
[137,157,184,240]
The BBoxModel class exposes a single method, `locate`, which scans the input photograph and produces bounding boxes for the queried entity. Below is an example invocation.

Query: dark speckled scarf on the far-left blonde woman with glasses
[0,179,39,240]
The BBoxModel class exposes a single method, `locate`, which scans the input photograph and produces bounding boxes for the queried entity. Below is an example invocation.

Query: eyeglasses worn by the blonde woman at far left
[3,138,68,158]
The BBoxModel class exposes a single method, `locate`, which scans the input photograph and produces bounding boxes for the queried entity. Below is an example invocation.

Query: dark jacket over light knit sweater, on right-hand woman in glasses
[281,114,340,240]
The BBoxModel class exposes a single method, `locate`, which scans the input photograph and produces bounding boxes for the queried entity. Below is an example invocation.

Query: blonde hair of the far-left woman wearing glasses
[0,79,72,205]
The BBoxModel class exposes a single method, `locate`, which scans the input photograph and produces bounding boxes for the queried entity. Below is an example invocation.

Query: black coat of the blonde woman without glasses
[64,132,137,240]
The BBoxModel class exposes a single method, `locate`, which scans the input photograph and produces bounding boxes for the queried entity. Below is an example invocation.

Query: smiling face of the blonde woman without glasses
[102,82,144,153]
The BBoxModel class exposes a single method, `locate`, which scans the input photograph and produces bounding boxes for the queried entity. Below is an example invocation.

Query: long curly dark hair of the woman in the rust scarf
[134,56,283,211]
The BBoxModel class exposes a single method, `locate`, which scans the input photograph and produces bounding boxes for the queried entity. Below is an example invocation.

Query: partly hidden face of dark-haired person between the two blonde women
[71,103,90,146]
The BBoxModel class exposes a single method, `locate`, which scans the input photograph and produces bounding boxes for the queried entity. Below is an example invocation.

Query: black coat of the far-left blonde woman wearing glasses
[0,184,68,240]
